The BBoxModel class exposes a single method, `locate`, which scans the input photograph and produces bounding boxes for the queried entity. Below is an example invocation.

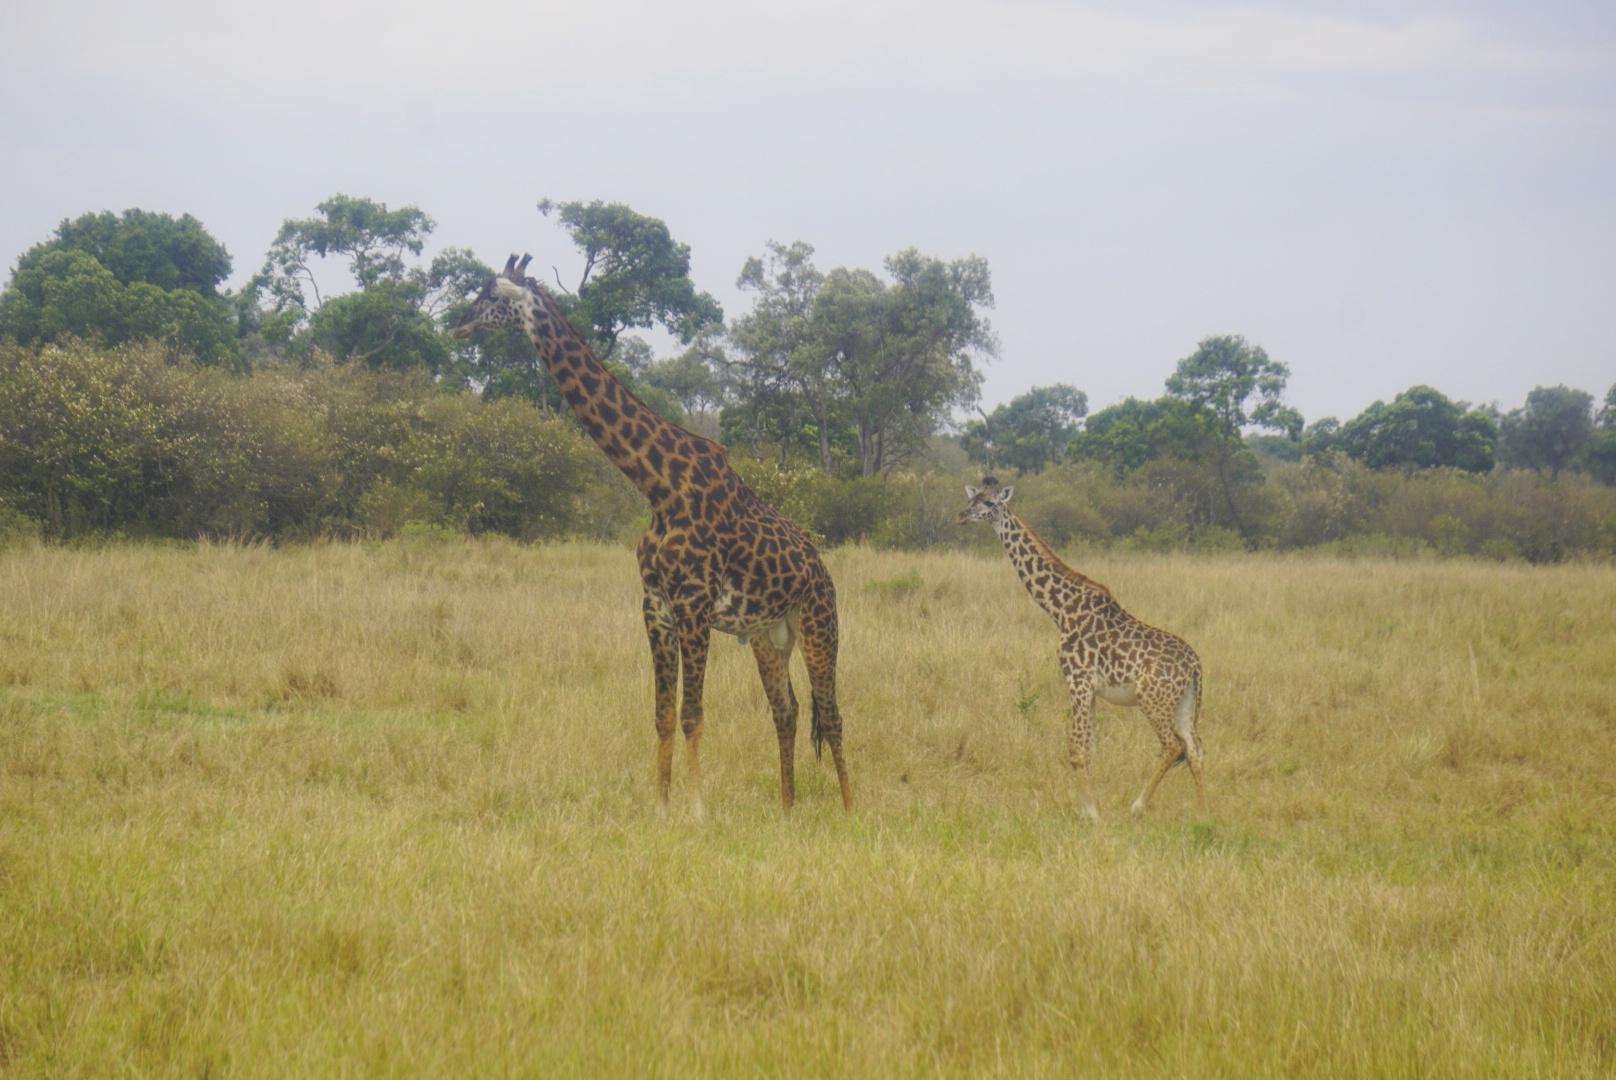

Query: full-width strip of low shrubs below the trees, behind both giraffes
[0,343,1616,561]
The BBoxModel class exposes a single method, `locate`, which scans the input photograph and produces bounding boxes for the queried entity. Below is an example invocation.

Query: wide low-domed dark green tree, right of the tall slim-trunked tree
[1325,385,1498,472]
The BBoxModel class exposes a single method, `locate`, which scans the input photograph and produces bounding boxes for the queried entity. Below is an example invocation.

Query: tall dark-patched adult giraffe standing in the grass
[452,255,853,818]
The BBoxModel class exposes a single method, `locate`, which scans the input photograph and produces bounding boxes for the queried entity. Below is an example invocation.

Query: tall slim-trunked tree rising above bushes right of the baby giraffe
[1167,335,1302,540]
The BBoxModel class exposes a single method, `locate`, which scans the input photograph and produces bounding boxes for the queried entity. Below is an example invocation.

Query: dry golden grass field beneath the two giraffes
[0,543,1616,1077]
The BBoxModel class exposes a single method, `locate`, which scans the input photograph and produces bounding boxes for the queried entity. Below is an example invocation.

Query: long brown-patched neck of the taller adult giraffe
[522,285,726,506]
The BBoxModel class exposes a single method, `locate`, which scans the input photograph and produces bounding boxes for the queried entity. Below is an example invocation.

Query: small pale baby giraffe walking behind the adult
[958,477,1207,821]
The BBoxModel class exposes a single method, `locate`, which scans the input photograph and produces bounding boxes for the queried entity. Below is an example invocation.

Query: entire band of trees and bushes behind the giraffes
[0,196,1616,561]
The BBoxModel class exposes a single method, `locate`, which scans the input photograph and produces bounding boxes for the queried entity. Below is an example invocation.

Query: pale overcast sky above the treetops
[0,0,1616,420]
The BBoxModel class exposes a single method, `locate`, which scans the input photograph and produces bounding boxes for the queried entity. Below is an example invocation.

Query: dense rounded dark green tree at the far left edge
[0,210,239,364]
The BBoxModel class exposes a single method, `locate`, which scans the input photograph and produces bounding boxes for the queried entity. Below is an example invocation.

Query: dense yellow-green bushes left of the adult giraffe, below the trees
[0,344,621,538]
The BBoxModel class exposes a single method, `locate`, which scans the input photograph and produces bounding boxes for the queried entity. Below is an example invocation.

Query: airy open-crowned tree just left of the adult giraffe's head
[250,194,493,372]
